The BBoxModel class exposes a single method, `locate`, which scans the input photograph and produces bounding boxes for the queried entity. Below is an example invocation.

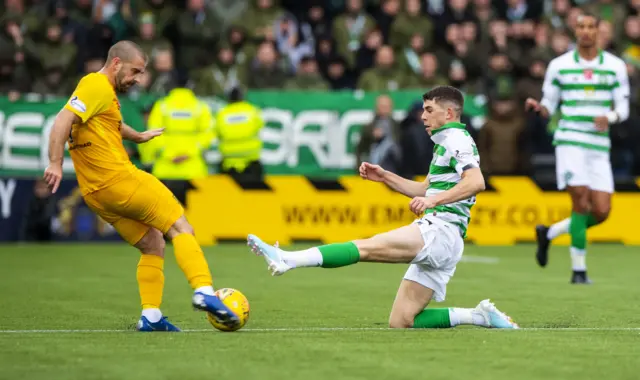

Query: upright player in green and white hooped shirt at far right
[526,14,629,284]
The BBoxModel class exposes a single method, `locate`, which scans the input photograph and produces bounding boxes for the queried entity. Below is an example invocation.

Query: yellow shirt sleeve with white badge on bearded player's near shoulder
[64,77,114,123]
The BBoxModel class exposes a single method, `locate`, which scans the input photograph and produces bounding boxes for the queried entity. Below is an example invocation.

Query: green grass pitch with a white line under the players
[0,244,640,380]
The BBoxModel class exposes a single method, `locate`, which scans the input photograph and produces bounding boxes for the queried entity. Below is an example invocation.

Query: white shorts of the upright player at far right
[556,145,614,193]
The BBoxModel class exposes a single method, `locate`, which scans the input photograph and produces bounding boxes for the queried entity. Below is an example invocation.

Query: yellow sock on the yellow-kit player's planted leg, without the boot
[136,254,164,310]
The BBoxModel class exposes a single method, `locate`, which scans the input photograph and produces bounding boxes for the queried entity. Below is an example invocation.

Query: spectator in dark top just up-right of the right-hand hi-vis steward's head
[248,41,287,90]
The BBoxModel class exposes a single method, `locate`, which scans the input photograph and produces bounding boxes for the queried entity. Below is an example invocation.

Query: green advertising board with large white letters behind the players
[0,91,485,177]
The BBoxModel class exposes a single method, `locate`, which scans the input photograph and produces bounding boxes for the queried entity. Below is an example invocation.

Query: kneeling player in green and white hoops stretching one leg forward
[248,86,518,329]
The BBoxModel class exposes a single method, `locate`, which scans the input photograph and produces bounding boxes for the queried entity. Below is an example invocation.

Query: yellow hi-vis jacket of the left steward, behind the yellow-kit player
[140,88,214,180]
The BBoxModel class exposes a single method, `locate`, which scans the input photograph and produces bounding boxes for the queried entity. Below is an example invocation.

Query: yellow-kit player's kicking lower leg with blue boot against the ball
[166,215,239,327]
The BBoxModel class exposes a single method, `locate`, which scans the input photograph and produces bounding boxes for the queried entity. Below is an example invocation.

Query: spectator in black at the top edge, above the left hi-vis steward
[177,0,222,71]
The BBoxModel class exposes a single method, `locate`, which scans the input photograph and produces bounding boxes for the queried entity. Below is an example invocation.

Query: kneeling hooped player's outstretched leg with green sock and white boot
[247,224,425,276]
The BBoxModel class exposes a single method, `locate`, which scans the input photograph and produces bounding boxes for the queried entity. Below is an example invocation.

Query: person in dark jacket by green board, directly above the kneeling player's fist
[356,95,402,173]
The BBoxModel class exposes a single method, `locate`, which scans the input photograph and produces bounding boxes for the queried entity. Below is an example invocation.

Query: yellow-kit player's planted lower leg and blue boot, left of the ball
[135,228,180,332]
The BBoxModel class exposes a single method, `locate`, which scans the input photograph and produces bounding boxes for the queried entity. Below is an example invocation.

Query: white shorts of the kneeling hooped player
[404,216,464,302]
